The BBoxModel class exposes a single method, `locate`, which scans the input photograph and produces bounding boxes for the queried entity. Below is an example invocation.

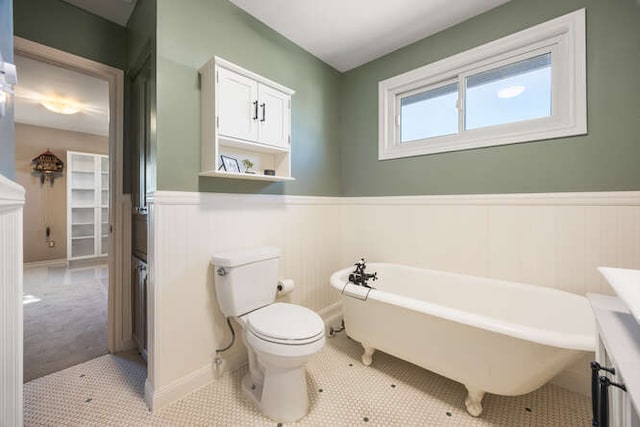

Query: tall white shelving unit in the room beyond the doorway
[67,151,109,260]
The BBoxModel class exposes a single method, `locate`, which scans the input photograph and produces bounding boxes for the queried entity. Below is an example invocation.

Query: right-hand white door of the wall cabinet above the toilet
[258,85,290,148]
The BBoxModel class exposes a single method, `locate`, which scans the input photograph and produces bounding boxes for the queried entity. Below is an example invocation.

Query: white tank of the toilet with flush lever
[211,247,280,317]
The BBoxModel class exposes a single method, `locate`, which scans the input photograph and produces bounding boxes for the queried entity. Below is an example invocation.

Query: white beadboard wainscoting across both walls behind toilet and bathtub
[146,191,640,409]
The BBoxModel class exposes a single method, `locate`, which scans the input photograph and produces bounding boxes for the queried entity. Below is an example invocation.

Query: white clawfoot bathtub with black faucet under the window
[331,263,595,416]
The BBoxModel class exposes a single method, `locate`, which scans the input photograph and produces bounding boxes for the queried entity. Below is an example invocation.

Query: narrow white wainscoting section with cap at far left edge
[0,175,25,426]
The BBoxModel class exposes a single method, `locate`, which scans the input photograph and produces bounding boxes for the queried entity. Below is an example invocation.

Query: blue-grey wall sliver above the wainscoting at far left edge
[0,0,16,179]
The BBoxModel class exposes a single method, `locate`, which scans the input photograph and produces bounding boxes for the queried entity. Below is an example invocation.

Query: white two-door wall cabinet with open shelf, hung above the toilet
[200,57,295,181]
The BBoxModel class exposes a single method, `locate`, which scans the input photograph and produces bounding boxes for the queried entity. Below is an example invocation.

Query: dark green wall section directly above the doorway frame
[13,0,127,70]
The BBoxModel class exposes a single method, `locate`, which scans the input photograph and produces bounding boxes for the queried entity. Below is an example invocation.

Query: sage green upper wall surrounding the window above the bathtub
[341,0,640,196]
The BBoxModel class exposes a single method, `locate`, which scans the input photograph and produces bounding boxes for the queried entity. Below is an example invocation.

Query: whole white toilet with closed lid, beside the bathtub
[211,248,325,422]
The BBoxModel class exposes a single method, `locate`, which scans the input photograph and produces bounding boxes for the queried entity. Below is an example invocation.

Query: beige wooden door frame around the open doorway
[13,37,134,353]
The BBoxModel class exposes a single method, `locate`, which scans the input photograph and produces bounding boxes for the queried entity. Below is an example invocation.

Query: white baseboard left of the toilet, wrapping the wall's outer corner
[144,365,214,412]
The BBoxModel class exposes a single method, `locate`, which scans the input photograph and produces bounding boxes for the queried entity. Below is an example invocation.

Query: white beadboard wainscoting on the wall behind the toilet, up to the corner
[146,192,342,410]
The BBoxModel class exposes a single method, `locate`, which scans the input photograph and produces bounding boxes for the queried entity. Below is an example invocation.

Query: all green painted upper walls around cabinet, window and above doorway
[7,0,640,196]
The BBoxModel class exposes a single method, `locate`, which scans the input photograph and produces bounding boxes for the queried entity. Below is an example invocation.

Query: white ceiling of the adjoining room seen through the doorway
[14,55,109,135]
